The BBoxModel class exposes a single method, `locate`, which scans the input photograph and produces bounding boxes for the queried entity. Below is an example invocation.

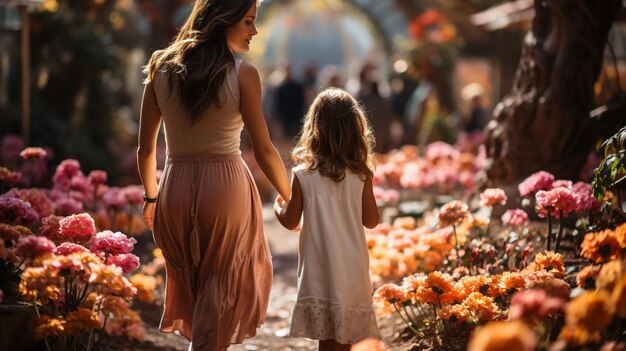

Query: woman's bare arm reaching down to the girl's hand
[238,62,291,199]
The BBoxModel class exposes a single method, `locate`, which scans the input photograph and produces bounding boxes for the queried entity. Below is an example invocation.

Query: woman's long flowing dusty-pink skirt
[154,154,272,351]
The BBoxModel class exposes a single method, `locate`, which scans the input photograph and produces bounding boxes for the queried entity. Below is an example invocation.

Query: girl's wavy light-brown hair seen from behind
[291,88,375,182]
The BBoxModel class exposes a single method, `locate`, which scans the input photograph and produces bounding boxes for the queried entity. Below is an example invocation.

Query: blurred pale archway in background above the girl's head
[248,0,408,84]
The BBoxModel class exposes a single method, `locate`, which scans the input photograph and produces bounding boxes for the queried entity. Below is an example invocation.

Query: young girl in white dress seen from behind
[274,88,378,351]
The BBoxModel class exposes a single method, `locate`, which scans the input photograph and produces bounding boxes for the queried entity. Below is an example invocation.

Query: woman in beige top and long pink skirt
[137,0,291,350]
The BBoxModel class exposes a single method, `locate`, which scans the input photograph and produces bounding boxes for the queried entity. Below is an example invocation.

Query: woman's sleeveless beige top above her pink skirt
[153,59,244,156]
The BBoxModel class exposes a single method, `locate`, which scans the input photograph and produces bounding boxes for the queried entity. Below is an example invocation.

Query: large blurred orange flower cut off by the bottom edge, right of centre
[467,320,539,351]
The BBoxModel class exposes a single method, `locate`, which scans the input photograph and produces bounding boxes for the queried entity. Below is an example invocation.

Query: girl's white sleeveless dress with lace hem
[289,167,378,344]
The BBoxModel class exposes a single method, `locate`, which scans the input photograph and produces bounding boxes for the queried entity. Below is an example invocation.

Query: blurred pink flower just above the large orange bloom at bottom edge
[509,289,565,320]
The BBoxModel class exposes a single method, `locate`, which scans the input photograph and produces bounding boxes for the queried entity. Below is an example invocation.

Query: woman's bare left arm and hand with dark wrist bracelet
[137,82,161,230]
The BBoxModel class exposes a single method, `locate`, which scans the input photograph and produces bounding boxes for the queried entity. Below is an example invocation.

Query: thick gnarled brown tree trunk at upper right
[483,0,622,187]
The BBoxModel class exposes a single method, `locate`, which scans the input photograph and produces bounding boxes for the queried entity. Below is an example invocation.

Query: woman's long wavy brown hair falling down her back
[146,0,258,124]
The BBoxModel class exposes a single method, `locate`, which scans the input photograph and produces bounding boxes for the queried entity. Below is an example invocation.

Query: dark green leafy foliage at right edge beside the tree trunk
[591,126,626,201]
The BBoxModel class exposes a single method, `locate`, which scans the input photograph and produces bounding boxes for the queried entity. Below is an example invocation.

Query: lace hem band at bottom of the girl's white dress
[289,299,378,344]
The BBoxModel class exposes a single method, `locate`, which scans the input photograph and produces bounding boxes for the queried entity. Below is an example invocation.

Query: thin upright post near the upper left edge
[19,5,30,146]
